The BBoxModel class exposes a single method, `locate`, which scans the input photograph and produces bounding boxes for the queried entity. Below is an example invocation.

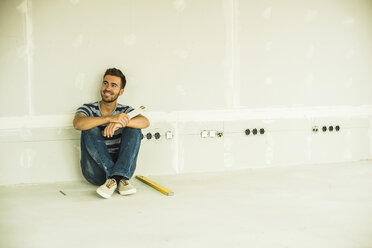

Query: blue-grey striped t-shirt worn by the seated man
[76,101,134,156]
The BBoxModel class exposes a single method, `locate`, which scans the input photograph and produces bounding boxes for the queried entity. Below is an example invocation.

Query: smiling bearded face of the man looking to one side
[101,75,124,103]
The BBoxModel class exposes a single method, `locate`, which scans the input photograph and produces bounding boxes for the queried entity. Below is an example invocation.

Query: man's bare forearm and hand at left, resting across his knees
[73,113,130,131]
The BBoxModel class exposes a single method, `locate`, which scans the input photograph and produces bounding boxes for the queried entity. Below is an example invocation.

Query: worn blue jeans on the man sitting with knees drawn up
[80,127,142,185]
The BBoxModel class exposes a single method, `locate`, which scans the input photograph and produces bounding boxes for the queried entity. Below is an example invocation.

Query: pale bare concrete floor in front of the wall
[0,162,372,248]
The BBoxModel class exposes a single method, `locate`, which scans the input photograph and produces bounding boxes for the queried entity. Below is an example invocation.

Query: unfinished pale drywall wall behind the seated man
[0,0,372,184]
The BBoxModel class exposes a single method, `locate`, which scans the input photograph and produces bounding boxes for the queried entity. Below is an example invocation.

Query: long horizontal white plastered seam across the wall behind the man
[0,105,372,130]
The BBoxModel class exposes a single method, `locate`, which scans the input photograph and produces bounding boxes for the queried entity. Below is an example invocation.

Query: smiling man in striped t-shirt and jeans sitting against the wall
[73,68,150,198]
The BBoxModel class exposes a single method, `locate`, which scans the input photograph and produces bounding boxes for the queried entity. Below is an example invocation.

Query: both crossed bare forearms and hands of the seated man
[73,113,150,137]
